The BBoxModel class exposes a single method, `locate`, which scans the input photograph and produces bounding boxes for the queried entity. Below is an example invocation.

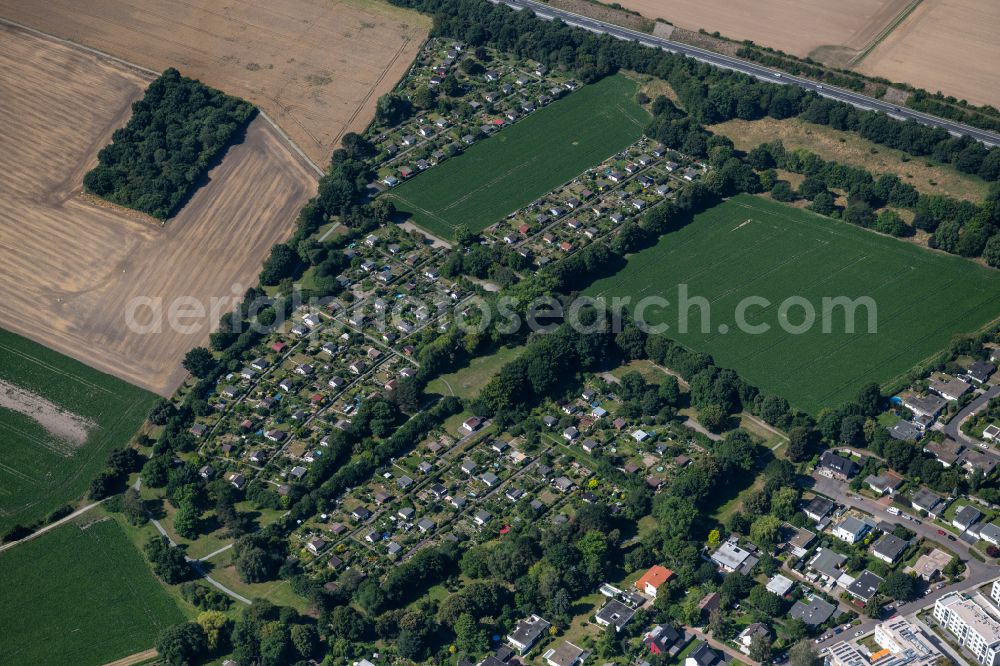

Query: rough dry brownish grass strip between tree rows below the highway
[708,118,988,202]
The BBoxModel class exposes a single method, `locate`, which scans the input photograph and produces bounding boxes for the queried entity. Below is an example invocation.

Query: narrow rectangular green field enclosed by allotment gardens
[389,76,649,238]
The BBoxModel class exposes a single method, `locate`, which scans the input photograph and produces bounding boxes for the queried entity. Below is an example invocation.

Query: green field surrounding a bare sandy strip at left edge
[0,329,157,533]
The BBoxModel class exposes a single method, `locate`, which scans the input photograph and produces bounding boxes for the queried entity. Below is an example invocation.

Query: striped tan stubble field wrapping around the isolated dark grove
[0,27,316,395]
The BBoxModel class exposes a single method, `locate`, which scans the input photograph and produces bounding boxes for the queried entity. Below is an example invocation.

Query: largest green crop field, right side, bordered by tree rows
[587,195,1000,414]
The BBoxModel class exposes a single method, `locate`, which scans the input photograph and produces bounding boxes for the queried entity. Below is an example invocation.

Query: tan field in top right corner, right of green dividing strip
[858,0,1000,107]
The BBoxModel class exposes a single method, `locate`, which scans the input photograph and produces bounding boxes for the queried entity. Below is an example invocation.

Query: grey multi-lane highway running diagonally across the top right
[490,0,1000,146]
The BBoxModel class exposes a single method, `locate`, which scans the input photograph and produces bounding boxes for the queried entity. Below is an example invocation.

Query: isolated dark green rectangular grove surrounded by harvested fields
[83,68,256,220]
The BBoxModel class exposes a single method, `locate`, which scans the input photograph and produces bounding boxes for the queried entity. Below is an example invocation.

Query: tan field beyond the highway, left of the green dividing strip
[604,0,909,57]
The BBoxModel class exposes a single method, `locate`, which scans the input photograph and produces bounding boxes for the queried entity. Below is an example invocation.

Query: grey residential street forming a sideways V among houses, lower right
[814,476,1000,648]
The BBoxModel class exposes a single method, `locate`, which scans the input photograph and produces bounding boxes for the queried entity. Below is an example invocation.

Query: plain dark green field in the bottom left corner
[0,518,184,665]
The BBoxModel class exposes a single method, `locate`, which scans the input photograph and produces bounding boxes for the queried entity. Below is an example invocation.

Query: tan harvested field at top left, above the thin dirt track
[0,0,430,167]
